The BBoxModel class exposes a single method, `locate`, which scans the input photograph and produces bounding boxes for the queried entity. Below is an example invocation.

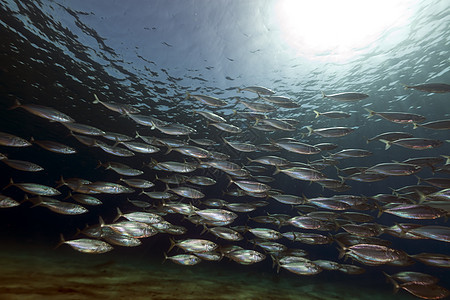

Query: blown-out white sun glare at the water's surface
[275,0,412,60]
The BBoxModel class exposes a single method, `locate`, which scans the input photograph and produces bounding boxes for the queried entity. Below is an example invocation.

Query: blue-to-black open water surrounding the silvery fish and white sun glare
[0,1,450,298]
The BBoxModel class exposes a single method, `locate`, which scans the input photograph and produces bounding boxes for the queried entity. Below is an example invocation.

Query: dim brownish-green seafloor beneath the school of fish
[0,241,417,300]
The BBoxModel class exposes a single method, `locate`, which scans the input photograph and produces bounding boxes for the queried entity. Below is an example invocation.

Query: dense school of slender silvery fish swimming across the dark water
[0,83,450,299]
